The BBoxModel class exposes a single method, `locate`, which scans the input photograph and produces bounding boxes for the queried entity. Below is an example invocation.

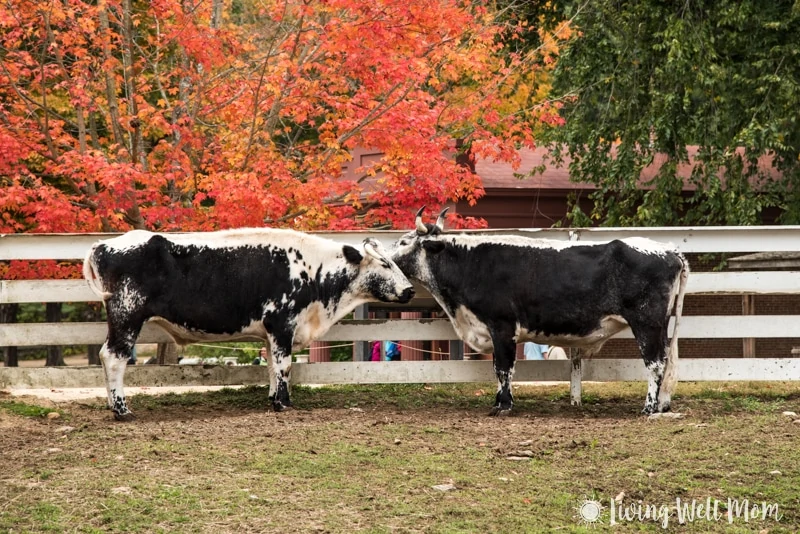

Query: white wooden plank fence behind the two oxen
[0,226,800,399]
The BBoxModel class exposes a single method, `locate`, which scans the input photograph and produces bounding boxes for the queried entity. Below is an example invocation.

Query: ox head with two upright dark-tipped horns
[392,206,448,284]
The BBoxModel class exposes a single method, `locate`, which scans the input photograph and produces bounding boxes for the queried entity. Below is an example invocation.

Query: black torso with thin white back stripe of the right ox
[428,238,684,352]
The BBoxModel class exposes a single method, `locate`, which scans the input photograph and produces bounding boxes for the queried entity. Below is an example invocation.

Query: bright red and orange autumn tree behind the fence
[0,0,555,240]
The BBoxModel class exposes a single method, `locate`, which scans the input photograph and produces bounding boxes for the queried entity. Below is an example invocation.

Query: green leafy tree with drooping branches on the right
[536,0,800,226]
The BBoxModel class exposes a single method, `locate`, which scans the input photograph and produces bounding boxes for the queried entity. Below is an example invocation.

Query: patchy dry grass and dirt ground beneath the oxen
[0,383,800,533]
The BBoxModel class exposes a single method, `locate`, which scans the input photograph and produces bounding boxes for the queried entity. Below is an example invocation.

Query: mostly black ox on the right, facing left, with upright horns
[391,209,689,415]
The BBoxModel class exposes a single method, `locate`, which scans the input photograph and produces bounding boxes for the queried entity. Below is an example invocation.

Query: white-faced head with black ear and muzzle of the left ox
[342,237,414,303]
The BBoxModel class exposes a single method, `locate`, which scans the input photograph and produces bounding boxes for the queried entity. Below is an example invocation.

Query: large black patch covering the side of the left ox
[94,235,346,348]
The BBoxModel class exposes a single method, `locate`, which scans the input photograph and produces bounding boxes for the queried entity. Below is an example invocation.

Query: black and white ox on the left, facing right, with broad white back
[83,229,414,420]
